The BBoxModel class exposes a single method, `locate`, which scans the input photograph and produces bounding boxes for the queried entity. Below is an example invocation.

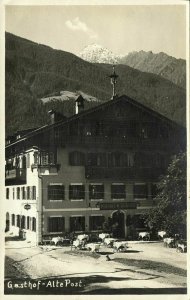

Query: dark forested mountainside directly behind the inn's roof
[6,33,185,134]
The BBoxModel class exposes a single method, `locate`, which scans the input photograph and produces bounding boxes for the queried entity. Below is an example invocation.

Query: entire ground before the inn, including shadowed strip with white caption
[5,238,187,294]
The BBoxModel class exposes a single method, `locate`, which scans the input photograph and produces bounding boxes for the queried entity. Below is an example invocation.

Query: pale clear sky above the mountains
[5,5,186,58]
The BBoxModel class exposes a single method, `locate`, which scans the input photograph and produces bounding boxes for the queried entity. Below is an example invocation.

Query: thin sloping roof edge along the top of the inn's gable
[6,95,183,148]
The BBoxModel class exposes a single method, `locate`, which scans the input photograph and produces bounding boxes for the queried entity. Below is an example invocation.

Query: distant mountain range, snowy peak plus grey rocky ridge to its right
[79,44,186,89]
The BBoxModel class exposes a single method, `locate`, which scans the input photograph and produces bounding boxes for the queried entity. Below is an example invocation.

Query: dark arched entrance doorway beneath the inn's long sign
[112,210,125,238]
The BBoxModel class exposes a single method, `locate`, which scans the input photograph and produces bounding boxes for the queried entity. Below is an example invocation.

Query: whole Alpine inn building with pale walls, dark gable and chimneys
[5,95,185,244]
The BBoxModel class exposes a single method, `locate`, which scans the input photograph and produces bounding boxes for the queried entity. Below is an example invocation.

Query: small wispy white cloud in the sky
[65,17,98,38]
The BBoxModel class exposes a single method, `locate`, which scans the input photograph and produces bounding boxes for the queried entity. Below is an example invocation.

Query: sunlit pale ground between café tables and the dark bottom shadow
[6,234,187,292]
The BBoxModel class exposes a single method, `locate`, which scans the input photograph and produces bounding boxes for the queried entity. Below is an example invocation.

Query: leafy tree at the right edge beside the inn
[146,153,187,236]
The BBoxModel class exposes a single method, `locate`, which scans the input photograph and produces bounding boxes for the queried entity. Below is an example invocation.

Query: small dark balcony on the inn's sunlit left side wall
[5,168,26,184]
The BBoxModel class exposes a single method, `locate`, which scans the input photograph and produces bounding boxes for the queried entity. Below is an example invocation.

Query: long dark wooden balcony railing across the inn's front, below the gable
[85,166,164,179]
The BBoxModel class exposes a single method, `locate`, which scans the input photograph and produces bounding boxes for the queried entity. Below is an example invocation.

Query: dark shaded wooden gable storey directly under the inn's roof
[6,96,186,157]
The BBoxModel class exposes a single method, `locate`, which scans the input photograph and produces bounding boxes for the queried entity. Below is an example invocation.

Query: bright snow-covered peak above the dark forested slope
[78,44,121,64]
